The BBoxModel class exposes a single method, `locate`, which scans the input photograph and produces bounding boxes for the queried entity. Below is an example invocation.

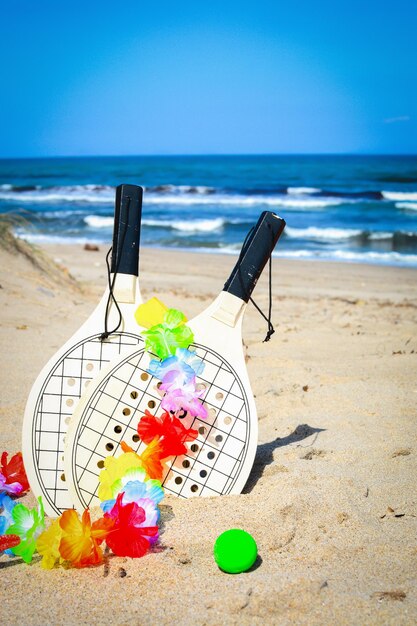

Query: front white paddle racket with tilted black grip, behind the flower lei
[65,212,285,510]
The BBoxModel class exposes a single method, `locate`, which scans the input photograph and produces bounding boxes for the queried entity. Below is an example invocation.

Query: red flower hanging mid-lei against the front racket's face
[138,411,198,459]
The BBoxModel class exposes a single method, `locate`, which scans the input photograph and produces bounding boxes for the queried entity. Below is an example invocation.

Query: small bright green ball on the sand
[213,528,258,574]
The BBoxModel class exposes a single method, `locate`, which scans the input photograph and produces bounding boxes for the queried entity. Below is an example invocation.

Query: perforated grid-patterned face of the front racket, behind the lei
[71,345,250,507]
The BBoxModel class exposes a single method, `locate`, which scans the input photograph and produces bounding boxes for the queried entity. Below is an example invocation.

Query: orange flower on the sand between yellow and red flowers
[59,509,114,567]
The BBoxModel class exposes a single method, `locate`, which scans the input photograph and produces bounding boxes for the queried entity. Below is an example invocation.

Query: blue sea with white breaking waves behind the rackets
[0,156,417,266]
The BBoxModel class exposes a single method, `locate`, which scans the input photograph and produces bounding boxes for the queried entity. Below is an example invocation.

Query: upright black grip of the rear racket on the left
[111,185,143,276]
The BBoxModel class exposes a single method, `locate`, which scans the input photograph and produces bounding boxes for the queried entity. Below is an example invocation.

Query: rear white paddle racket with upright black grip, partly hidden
[22,185,143,517]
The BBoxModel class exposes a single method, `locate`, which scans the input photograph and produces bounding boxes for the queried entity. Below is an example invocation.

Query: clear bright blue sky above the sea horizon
[0,0,417,157]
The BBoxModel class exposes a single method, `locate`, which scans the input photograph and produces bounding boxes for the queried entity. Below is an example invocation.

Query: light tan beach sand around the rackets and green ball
[0,240,417,625]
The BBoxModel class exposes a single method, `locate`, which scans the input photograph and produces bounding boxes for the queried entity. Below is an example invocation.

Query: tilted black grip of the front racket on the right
[224,211,285,302]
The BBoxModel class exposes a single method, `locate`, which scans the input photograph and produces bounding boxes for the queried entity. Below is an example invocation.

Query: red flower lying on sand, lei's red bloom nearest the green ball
[104,493,158,557]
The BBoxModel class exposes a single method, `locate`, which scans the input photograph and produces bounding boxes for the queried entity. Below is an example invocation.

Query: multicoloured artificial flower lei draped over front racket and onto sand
[0,298,207,569]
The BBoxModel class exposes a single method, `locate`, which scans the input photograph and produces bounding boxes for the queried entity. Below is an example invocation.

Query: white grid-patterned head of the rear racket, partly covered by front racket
[22,298,143,517]
